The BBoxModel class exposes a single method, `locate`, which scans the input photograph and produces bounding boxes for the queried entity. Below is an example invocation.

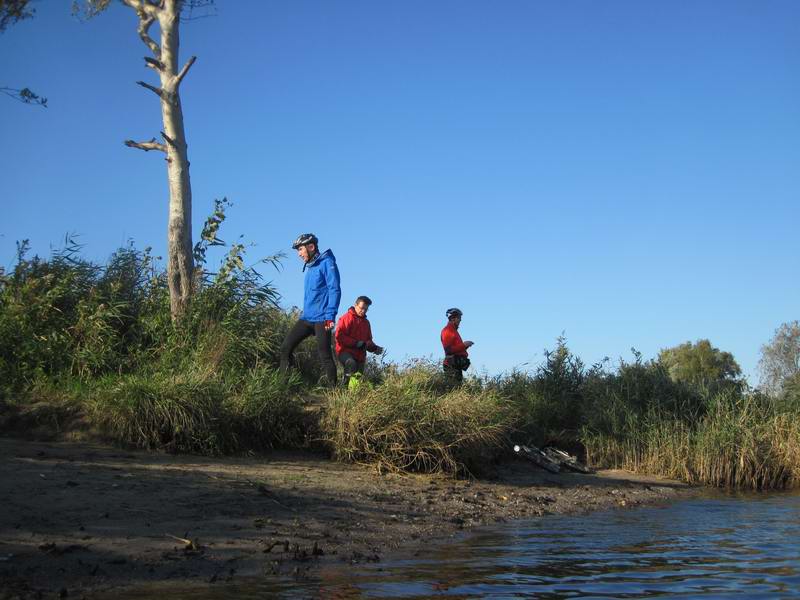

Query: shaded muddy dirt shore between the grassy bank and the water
[0,437,692,600]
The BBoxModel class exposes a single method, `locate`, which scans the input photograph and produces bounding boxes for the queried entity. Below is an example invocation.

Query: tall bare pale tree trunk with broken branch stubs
[123,0,195,321]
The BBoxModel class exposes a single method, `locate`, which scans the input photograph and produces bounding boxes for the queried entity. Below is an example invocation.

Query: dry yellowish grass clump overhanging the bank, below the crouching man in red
[321,364,512,474]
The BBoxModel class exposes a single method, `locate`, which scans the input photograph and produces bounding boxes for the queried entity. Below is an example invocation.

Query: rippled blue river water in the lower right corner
[270,494,800,600]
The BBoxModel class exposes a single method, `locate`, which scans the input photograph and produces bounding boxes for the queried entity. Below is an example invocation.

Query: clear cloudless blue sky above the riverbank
[0,0,800,383]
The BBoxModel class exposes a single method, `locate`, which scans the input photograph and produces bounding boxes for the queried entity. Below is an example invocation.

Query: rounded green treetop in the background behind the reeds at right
[658,340,742,386]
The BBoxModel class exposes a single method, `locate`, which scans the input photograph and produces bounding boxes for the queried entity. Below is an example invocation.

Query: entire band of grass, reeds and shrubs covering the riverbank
[0,232,800,489]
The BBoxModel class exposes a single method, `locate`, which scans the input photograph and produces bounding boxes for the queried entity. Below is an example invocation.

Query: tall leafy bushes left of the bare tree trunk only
[0,237,172,390]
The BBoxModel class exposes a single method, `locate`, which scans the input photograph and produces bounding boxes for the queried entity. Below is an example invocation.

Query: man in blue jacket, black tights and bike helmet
[281,233,342,386]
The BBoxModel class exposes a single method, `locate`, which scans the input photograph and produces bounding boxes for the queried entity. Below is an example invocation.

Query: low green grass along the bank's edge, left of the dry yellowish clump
[83,368,304,454]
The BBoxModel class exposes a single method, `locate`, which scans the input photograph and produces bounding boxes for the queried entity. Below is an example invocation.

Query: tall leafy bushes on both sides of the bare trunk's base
[0,201,288,391]
